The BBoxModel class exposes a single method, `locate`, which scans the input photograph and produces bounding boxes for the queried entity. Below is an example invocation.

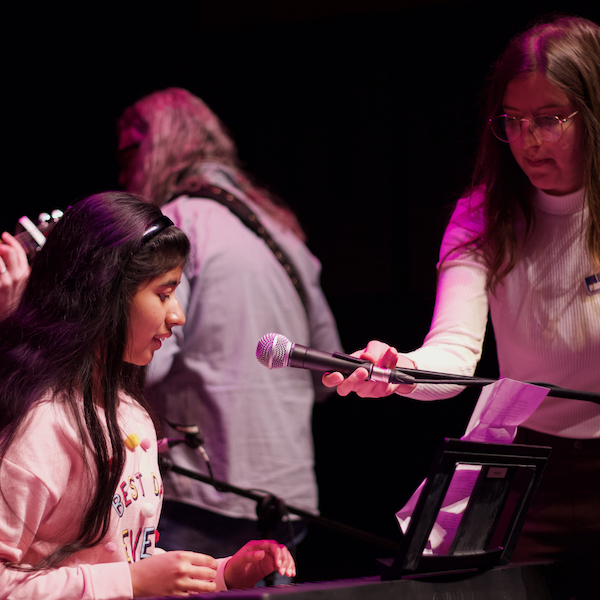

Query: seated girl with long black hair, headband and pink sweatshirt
[0,192,295,599]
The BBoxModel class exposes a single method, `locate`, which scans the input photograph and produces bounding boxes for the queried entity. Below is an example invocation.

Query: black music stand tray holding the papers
[379,439,551,580]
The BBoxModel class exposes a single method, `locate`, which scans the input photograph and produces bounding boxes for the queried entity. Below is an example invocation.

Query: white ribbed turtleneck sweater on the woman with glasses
[405,185,600,438]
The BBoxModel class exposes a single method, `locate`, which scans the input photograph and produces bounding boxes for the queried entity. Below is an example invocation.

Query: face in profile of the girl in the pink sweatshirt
[124,266,185,367]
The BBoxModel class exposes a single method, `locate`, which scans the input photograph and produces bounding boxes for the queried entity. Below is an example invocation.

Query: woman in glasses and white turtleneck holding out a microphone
[324,17,600,590]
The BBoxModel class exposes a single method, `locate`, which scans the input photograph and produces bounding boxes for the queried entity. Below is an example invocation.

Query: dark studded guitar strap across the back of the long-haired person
[170,185,307,310]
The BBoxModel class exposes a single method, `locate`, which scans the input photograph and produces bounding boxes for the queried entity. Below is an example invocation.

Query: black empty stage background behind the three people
[5,0,600,581]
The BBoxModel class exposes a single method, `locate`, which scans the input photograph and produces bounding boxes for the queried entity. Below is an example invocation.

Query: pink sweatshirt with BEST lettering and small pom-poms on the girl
[0,394,226,600]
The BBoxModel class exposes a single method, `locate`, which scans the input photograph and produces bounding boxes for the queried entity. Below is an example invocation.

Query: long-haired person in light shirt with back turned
[119,88,341,580]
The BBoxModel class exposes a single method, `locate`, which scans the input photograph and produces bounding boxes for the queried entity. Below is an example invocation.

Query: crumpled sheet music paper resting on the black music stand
[396,379,549,554]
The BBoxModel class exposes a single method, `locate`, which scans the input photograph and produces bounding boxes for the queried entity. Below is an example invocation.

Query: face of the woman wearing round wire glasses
[502,71,584,196]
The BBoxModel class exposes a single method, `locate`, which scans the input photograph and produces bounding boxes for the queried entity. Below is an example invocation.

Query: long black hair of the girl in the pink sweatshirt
[0,192,190,569]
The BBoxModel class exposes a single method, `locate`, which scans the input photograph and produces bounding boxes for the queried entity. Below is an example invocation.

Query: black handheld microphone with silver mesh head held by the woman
[256,333,416,385]
